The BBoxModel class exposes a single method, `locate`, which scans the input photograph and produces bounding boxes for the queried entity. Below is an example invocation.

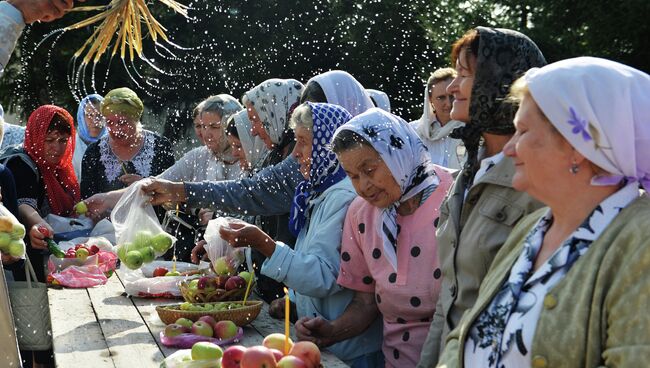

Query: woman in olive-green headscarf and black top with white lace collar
[81,87,174,198]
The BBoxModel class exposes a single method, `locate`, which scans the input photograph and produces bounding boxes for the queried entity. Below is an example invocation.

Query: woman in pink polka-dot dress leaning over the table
[296,108,452,367]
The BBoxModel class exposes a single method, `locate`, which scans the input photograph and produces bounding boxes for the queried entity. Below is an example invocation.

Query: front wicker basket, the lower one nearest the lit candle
[156,300,264,326]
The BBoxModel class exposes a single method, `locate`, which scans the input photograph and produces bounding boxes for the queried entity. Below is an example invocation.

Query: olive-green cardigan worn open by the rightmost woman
[439,195,650,368]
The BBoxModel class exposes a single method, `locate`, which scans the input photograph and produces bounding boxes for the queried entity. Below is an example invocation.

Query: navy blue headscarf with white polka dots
[289,102,352,236]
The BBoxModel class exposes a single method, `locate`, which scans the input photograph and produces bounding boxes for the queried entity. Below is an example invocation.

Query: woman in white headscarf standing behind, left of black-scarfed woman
[411,68,465,170]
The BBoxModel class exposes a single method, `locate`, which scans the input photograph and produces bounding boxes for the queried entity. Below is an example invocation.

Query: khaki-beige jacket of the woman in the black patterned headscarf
[418,157,542,368]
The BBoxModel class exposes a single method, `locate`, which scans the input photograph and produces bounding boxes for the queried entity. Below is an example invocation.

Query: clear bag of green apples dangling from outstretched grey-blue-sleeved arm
[111,179,176,270]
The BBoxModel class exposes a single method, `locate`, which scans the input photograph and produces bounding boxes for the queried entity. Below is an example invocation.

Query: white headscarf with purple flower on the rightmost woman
[525,57,650,190]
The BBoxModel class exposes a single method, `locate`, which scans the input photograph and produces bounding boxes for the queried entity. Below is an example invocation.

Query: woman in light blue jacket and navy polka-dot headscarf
[221,103,381,367]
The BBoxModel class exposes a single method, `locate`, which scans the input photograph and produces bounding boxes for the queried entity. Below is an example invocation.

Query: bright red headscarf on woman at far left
[24,105,80,216]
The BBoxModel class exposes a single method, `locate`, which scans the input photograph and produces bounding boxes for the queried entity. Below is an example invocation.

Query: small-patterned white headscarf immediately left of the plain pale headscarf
[245,79,303,144]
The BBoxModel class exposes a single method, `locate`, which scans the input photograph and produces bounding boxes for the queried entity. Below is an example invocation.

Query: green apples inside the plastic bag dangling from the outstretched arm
[117,230,174,270]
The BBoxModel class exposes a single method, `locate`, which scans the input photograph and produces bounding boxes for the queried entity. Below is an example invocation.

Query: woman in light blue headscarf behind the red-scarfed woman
[72,94,106,182]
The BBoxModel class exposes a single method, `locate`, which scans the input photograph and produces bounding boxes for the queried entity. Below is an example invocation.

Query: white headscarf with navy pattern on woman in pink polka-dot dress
[334,108,440,270]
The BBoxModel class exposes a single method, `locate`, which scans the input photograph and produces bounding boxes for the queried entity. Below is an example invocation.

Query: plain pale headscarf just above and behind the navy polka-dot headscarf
[307,70,375,116]
